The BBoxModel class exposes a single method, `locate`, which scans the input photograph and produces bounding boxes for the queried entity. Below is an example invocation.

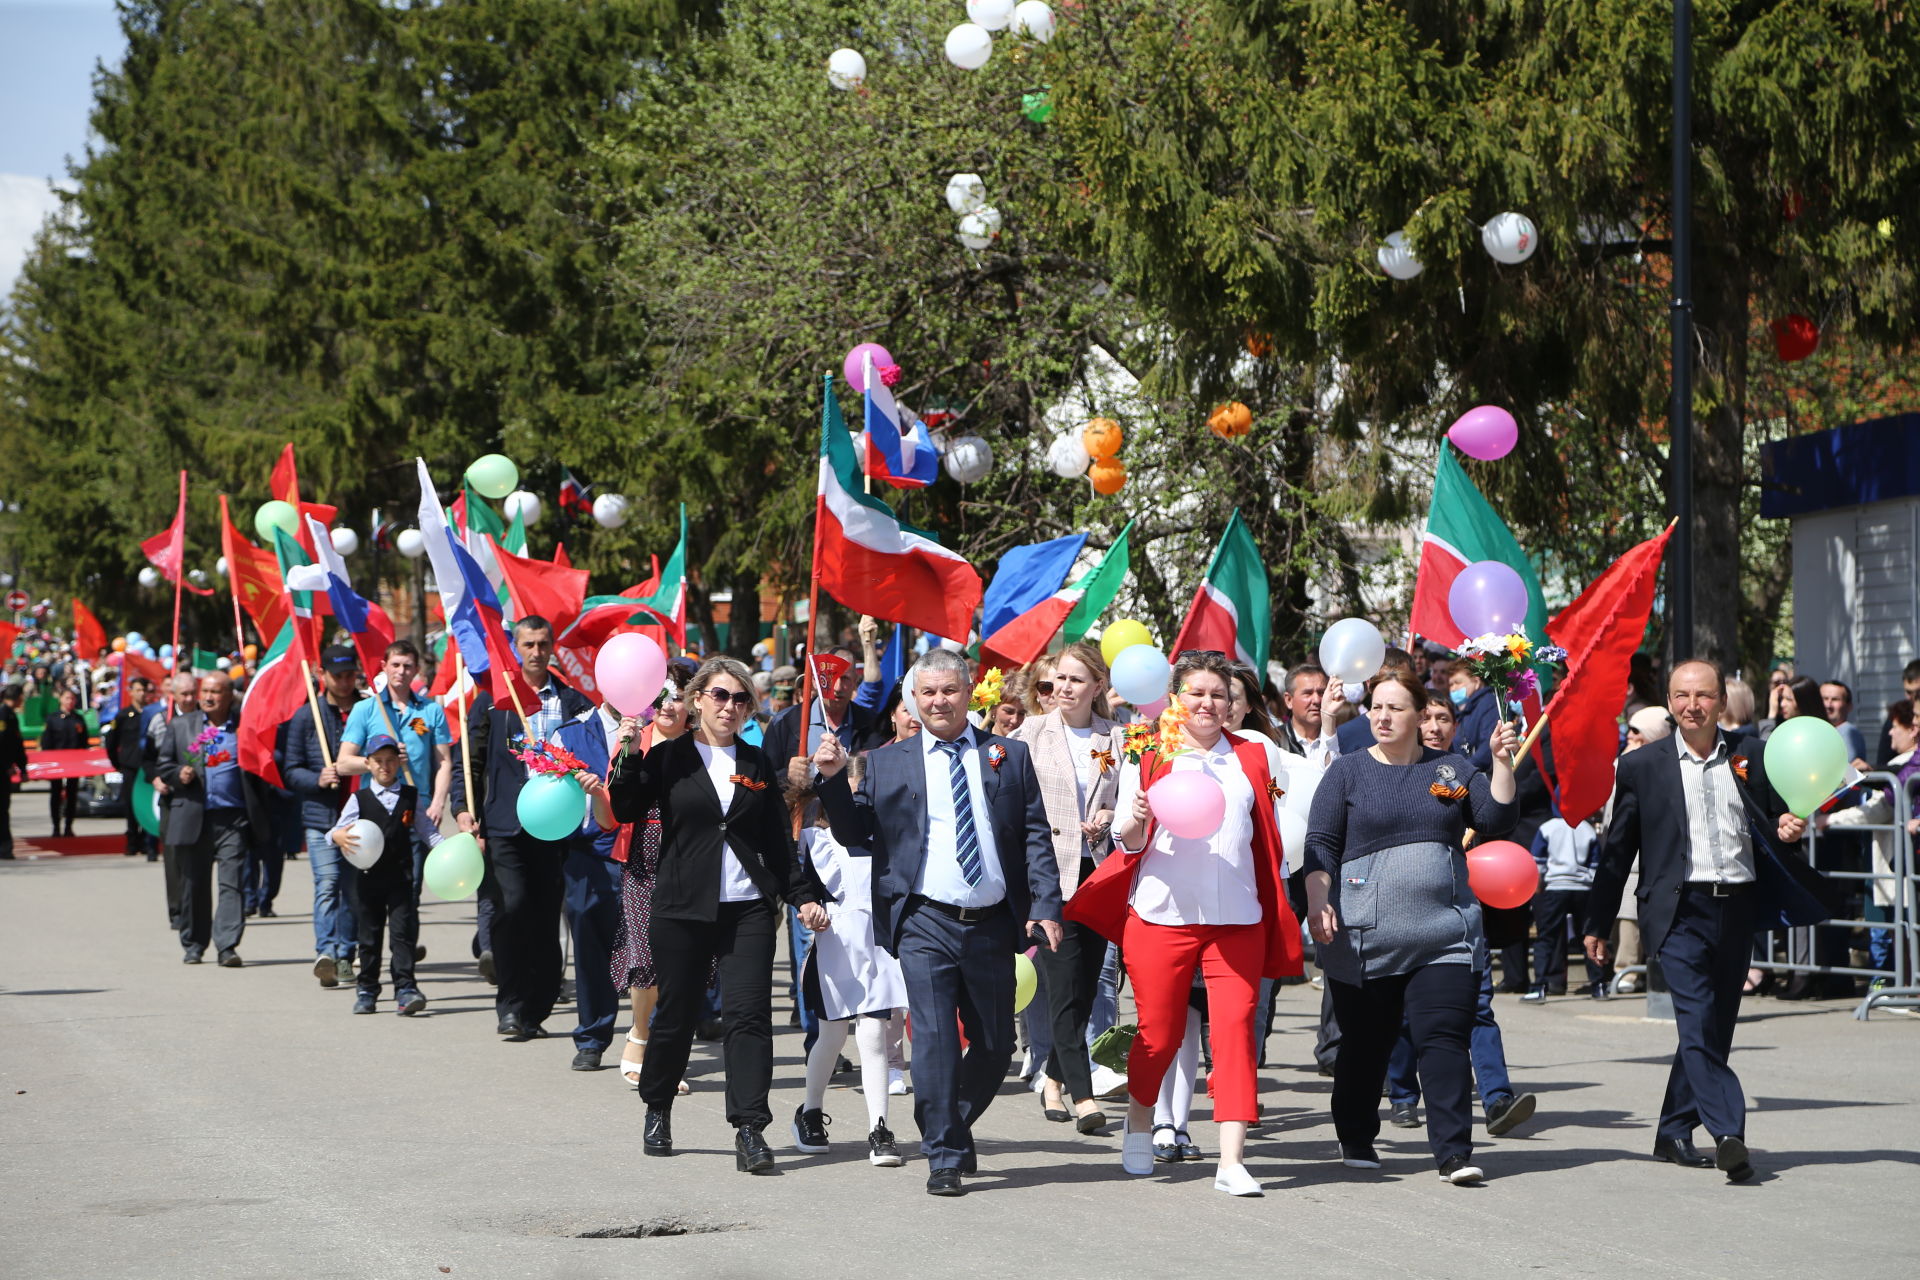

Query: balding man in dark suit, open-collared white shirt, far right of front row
[1586,660,1828,1182]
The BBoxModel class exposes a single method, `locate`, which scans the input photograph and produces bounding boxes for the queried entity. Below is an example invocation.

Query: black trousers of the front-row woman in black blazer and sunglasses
[645,898,780,1128]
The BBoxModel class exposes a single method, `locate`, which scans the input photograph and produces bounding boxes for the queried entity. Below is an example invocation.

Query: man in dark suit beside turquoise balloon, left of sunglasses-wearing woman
[453,614,593,1042]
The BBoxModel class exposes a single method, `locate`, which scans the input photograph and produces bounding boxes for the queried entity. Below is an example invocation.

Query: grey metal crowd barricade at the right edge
[1753,771,1920,1021]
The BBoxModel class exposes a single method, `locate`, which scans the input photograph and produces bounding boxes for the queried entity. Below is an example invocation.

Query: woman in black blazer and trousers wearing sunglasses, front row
[609,658,828,1173]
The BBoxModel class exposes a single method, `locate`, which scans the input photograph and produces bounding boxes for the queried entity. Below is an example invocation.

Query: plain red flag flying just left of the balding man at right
[1548,524,1672,823]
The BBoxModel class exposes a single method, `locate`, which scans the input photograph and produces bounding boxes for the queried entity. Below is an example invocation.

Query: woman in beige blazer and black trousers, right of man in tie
[1012,641,1119,1134]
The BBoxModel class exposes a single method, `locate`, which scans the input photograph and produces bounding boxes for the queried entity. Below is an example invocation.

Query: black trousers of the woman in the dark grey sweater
[1327,965,1480,1165]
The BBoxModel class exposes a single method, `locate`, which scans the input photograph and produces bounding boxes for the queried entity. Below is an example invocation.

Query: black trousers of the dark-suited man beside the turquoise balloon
[486,835,566,1025]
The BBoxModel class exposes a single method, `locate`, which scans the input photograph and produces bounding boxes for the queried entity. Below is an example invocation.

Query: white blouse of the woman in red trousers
[1114,737,1267,925]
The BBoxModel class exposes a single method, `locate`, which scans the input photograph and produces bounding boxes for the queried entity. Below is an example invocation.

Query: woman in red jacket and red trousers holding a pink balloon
[1066,651,1300,1196]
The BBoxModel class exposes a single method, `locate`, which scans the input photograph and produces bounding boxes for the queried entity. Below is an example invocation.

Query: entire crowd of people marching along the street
[0,618,1920,1196]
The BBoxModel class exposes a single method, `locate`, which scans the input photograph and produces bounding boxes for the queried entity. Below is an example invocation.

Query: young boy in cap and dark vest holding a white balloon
[326,733,426,1015]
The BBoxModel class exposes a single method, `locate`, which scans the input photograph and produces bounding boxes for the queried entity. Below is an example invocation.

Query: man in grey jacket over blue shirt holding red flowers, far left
[154,672,248,969]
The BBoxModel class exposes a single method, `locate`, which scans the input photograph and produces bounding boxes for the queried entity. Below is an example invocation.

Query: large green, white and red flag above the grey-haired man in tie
[814,374,981,637]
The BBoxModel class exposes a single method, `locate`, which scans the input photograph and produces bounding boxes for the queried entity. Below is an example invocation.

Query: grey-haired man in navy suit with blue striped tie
[814,651,1060,1196]
